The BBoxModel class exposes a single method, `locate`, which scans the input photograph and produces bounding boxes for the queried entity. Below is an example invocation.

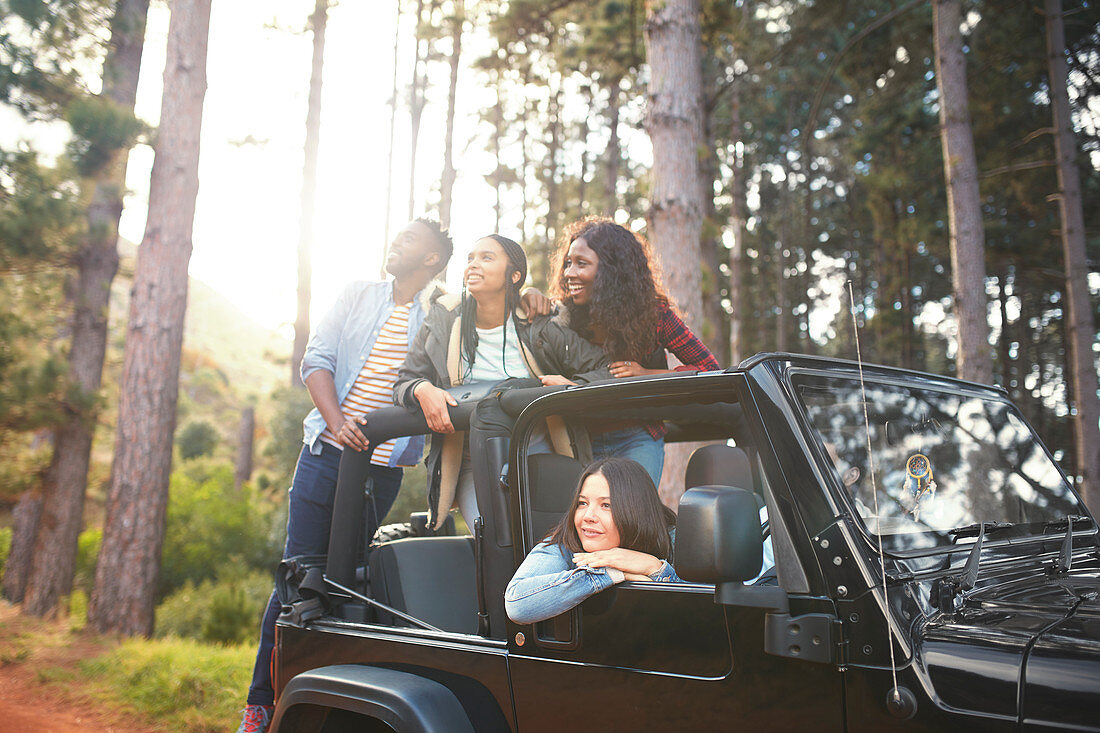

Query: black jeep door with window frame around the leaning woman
[508,373,844,732]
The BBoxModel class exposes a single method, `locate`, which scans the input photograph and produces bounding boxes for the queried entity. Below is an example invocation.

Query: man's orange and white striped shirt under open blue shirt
[321,305,418,466]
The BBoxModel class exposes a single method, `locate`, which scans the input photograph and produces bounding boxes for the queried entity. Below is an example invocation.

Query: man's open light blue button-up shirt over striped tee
[301,281,437,467]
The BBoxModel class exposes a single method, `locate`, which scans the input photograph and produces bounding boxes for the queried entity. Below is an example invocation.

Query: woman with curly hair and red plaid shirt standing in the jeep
[543,217,719,483]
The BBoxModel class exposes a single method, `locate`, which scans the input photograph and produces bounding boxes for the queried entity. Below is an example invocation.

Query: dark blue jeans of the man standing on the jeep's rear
[248,442,402,705]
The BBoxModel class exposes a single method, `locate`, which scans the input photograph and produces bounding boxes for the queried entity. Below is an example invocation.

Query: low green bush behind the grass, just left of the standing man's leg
[155,566,272,644]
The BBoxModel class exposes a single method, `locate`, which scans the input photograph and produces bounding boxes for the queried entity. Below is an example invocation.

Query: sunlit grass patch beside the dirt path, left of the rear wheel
[78,638,255,733]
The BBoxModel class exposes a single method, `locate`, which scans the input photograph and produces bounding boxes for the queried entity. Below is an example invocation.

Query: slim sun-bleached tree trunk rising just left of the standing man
[290,0,329,390]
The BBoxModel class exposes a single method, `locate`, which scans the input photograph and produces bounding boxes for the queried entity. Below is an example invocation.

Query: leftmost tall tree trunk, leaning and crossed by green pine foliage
[23,0,149,615]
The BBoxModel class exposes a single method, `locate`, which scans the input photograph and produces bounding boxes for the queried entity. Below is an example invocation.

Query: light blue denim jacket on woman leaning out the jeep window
[504,541,683,624]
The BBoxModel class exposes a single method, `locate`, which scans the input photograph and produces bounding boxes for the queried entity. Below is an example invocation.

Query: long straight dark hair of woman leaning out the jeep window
[548,457,677,560]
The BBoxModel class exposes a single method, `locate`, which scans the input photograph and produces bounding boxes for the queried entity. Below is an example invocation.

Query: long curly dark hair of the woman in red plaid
[553,217,669,361]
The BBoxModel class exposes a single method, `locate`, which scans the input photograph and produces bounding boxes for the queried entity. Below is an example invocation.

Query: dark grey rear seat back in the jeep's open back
[370,536,477,634]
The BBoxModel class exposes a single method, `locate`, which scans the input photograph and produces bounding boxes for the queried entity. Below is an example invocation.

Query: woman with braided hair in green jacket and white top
[394,234,611,527]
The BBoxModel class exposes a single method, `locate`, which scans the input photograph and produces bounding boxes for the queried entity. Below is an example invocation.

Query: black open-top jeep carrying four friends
[273,354,1100,733]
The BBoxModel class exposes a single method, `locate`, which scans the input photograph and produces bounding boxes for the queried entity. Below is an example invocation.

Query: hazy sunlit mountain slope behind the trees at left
[110,239,292,395]
